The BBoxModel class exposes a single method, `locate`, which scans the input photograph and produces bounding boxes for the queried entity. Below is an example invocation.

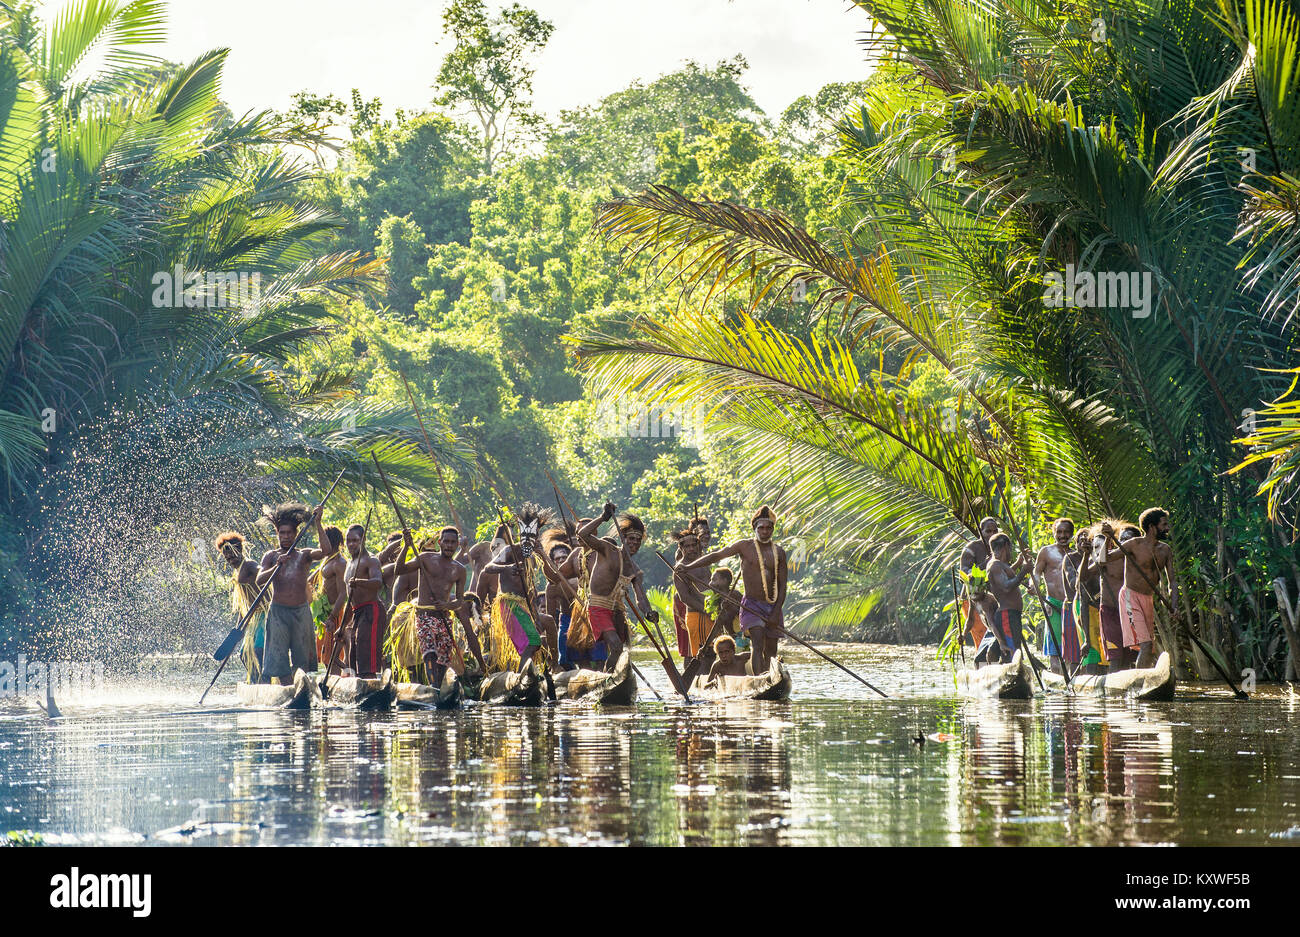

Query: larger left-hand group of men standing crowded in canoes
[215,503,788,686]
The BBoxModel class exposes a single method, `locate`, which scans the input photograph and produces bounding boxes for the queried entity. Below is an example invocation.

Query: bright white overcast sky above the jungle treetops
[71,0,867,117]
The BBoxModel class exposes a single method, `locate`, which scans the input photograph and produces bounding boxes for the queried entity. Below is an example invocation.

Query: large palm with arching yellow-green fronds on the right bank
[577,0,1300,670]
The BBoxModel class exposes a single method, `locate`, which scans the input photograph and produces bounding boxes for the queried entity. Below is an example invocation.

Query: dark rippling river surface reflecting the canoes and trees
[0,645,1300,846]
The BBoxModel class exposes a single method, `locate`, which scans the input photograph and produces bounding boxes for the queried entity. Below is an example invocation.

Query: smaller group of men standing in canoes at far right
[959,507,1178,673]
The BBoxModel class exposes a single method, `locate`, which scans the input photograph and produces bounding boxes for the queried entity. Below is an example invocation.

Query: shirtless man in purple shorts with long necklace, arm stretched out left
[675,504,788,673]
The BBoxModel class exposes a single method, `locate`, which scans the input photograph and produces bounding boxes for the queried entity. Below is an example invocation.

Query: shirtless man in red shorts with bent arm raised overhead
[577,502,659,668]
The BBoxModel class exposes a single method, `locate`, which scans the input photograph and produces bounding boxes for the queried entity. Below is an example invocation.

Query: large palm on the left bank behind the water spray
[0,0,472,649]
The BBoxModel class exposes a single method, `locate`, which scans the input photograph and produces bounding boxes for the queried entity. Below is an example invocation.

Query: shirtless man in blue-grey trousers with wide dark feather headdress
[256,502,332,682]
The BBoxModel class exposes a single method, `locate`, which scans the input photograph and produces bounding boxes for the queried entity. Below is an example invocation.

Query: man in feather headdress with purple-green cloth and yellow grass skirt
[484,502,551,672]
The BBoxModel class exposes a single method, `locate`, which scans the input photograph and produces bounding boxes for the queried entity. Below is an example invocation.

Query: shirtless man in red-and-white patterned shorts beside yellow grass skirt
[398,526,469,687]
